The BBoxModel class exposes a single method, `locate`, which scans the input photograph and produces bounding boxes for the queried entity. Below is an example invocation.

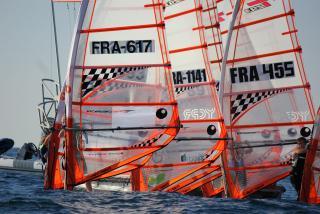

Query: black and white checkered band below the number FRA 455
[231,89,286,120]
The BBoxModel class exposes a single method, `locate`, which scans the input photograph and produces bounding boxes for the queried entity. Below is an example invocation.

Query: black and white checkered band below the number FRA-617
[81,67,146,97]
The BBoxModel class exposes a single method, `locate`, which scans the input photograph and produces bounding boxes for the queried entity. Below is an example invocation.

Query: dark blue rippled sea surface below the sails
[0,150,320,214]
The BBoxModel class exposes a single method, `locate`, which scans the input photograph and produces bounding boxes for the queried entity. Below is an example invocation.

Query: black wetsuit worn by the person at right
[291,153,306,195]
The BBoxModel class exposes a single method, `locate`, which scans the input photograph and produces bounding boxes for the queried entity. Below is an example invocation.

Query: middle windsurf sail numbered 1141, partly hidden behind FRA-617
[135,0,226,194]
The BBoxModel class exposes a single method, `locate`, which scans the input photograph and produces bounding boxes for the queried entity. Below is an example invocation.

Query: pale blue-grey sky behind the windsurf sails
[0,0,320,147]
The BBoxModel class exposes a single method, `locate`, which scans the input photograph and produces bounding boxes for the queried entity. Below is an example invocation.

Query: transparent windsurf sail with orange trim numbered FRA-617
[45,0,180,189]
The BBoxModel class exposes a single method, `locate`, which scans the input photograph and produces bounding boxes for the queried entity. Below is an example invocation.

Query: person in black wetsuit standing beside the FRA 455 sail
[291,137,308,196]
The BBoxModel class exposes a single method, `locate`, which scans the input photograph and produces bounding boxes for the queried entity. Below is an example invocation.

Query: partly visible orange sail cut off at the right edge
[300,108,320,204]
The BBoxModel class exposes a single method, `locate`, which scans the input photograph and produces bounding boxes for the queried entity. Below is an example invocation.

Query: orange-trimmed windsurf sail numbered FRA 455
[217,0,314,198]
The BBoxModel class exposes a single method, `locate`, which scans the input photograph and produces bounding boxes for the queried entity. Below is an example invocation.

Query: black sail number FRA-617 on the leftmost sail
[91,40,155,54]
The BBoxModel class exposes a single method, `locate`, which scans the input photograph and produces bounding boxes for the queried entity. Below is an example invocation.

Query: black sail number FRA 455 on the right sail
[230,61,295,84]
